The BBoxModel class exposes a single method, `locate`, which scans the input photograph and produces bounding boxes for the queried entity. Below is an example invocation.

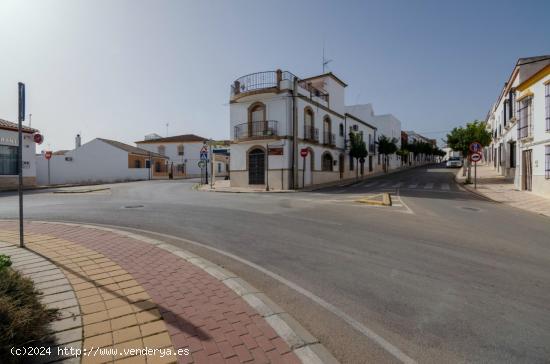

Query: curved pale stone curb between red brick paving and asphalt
[21,220,339,364]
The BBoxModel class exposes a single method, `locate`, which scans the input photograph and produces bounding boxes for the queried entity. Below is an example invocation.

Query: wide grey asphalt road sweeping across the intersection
[0,167,550,363]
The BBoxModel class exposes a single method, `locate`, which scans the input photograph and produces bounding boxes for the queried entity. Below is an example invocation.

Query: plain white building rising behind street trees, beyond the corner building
[346,104,401,170]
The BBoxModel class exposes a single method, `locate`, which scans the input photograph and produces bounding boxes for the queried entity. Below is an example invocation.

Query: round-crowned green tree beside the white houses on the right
[445,120,491,183]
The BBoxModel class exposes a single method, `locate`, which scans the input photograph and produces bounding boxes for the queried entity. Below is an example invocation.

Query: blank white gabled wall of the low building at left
[36,139,149,185]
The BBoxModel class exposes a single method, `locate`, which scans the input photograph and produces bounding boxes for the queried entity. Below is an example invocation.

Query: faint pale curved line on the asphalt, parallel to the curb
[46,221,416,364]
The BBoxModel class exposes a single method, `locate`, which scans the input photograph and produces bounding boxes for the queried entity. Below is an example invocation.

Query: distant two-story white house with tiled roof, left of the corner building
[135,134,208,178]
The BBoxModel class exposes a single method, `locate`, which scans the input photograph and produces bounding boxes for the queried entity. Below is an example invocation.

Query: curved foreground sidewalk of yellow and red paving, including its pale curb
[0,220,335,363]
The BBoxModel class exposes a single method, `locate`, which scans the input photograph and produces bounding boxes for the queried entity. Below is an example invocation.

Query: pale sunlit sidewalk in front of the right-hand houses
[456,165,550,217]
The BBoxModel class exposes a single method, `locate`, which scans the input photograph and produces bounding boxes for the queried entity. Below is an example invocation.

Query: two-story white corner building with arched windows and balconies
[230,70,376,189]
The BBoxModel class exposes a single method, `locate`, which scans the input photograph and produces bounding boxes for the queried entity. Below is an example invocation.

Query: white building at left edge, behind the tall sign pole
[0,119,38,189]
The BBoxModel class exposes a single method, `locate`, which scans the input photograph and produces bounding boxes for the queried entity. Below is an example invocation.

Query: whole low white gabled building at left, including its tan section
[36,137,168,185]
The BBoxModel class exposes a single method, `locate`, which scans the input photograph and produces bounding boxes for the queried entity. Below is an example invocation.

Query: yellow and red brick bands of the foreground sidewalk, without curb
[0,221,300,363]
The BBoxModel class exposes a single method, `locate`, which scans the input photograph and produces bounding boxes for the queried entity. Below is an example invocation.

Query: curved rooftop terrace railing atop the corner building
[231,70,296,100]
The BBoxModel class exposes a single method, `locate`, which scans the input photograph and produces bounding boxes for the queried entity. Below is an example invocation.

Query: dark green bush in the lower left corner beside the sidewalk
[0,266,57,358]
